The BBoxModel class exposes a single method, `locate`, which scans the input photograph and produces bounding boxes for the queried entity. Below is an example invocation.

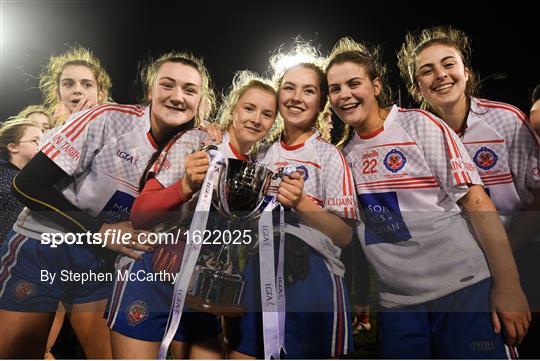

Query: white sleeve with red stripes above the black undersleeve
[41,106,113,176]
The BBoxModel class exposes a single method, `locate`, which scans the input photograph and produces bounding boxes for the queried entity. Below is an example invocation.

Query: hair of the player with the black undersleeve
[140,51,216,127]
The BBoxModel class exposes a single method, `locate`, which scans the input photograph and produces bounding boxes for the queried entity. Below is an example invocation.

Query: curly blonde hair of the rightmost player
[398,26,477,109]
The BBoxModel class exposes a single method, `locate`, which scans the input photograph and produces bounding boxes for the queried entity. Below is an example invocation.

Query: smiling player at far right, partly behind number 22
[398,27,540,356]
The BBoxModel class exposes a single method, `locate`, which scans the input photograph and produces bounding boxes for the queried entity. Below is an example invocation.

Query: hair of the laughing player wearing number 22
[326,37,392,148]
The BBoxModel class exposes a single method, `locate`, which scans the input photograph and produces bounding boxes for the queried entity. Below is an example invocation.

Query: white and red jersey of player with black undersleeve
[14,104,157,239]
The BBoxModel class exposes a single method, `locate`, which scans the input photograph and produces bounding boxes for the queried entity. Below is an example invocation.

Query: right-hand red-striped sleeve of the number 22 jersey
[402,110,482,202]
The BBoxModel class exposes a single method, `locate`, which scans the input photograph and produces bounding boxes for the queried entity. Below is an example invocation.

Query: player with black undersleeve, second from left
[0,53,208,358]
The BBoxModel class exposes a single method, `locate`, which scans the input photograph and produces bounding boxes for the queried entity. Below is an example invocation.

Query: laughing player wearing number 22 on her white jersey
[327,38,530,358]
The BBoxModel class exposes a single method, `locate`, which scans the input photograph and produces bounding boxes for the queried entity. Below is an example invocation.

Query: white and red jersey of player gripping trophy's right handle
[257,132,358,275]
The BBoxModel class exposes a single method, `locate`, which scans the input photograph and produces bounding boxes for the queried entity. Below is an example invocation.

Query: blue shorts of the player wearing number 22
[379,278,517,359]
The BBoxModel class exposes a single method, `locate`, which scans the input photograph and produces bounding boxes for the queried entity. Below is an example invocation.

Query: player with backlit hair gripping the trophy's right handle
[230,42,355,358]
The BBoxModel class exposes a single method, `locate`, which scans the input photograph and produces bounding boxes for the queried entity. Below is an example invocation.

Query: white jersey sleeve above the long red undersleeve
[152,129,208,187]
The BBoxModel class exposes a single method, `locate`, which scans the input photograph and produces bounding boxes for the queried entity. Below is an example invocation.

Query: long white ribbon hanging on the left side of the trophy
[158,150,223,360]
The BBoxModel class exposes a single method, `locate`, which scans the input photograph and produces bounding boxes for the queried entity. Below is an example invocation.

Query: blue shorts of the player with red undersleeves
[107,252,221,342]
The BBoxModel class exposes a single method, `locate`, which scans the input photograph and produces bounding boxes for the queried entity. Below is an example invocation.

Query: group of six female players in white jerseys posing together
[0,27,540,358]
